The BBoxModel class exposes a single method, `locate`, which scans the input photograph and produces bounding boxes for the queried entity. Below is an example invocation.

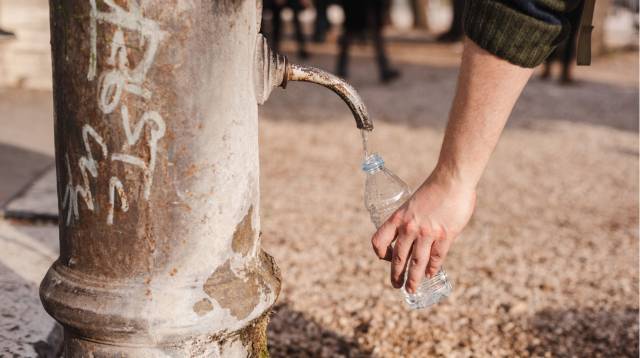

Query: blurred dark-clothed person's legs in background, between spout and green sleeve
[336,0,400,83]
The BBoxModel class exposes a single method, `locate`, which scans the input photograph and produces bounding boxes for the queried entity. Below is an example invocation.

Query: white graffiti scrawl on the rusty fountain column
[62,0,166,226]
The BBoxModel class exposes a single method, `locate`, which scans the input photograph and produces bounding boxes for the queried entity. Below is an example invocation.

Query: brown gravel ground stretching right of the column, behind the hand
[260,44,638,357]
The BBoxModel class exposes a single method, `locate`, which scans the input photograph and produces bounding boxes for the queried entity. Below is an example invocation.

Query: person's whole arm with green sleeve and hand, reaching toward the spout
[371,0,593,293]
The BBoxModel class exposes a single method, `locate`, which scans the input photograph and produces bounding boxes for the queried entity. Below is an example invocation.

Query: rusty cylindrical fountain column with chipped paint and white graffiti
[41,0,280,357]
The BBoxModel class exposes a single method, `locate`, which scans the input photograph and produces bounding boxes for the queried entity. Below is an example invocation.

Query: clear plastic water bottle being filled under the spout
[362,153,453,309]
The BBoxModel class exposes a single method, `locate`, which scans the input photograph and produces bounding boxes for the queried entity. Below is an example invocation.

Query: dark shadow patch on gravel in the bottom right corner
[527,307,638,357]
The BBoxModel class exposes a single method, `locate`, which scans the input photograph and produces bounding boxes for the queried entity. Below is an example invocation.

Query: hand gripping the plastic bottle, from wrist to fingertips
[371,169,476,293]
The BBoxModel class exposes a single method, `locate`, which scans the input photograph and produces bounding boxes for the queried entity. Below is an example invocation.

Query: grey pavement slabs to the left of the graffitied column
[0,84,62,357]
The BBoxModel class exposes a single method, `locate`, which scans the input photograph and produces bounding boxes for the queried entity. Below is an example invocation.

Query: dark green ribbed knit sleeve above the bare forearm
[464,0,581,67]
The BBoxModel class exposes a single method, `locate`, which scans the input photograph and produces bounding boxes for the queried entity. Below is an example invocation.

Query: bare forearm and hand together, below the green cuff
[371,39,533,292]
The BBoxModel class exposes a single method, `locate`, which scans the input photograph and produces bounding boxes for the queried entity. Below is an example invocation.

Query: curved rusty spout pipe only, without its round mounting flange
[282,63,373,131]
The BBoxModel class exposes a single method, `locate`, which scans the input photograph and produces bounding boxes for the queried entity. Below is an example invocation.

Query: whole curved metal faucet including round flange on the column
[256,35,373,131]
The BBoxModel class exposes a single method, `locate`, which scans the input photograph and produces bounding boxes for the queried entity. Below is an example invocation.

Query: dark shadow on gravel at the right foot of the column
[268,302,373,358]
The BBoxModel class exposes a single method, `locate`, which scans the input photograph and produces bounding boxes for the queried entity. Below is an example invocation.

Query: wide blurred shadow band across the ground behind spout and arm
[262,55,638,132]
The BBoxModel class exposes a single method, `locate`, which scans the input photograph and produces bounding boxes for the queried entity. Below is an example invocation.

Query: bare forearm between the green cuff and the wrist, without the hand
[434,39,533,189]
